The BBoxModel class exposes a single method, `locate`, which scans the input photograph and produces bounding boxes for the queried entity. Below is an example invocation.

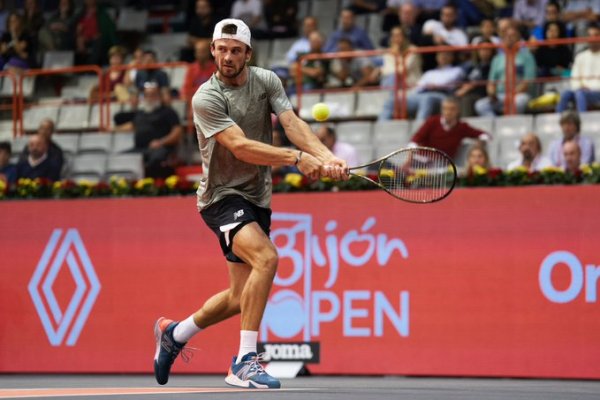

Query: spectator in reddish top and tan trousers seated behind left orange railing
[90,46,133,103]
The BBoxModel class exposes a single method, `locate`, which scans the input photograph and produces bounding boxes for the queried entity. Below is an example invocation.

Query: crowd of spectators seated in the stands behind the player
[0,0,600,184]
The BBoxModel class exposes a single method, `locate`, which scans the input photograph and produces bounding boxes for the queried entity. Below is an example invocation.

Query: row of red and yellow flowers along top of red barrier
[0,163,600,199]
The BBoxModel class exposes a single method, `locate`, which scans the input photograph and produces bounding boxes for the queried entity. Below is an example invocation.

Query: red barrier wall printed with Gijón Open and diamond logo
[0,186,600,379]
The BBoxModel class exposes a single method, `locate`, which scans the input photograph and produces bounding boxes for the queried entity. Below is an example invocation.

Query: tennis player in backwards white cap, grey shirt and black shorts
[154,19,347,388]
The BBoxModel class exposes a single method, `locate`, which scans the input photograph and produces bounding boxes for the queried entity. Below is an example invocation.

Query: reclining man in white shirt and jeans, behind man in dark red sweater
[406,51,464,120]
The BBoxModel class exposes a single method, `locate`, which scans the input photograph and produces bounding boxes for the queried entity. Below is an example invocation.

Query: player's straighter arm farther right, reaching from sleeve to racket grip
[279,110,348,179]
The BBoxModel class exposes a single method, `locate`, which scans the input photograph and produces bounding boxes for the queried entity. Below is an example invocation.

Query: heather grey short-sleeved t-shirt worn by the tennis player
[192,67,292,210]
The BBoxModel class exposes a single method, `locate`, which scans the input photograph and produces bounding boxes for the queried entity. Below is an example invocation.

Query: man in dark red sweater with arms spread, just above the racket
[409,98,490,158]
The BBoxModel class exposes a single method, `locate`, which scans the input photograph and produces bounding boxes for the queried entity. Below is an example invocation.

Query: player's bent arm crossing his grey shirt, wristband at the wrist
[215,124,323,179]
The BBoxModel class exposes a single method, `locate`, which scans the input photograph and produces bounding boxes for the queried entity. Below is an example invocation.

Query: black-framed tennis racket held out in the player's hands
[348,147,456,203]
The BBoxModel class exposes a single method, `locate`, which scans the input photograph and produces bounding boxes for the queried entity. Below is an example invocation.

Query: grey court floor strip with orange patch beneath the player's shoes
[0,375,600,400]
